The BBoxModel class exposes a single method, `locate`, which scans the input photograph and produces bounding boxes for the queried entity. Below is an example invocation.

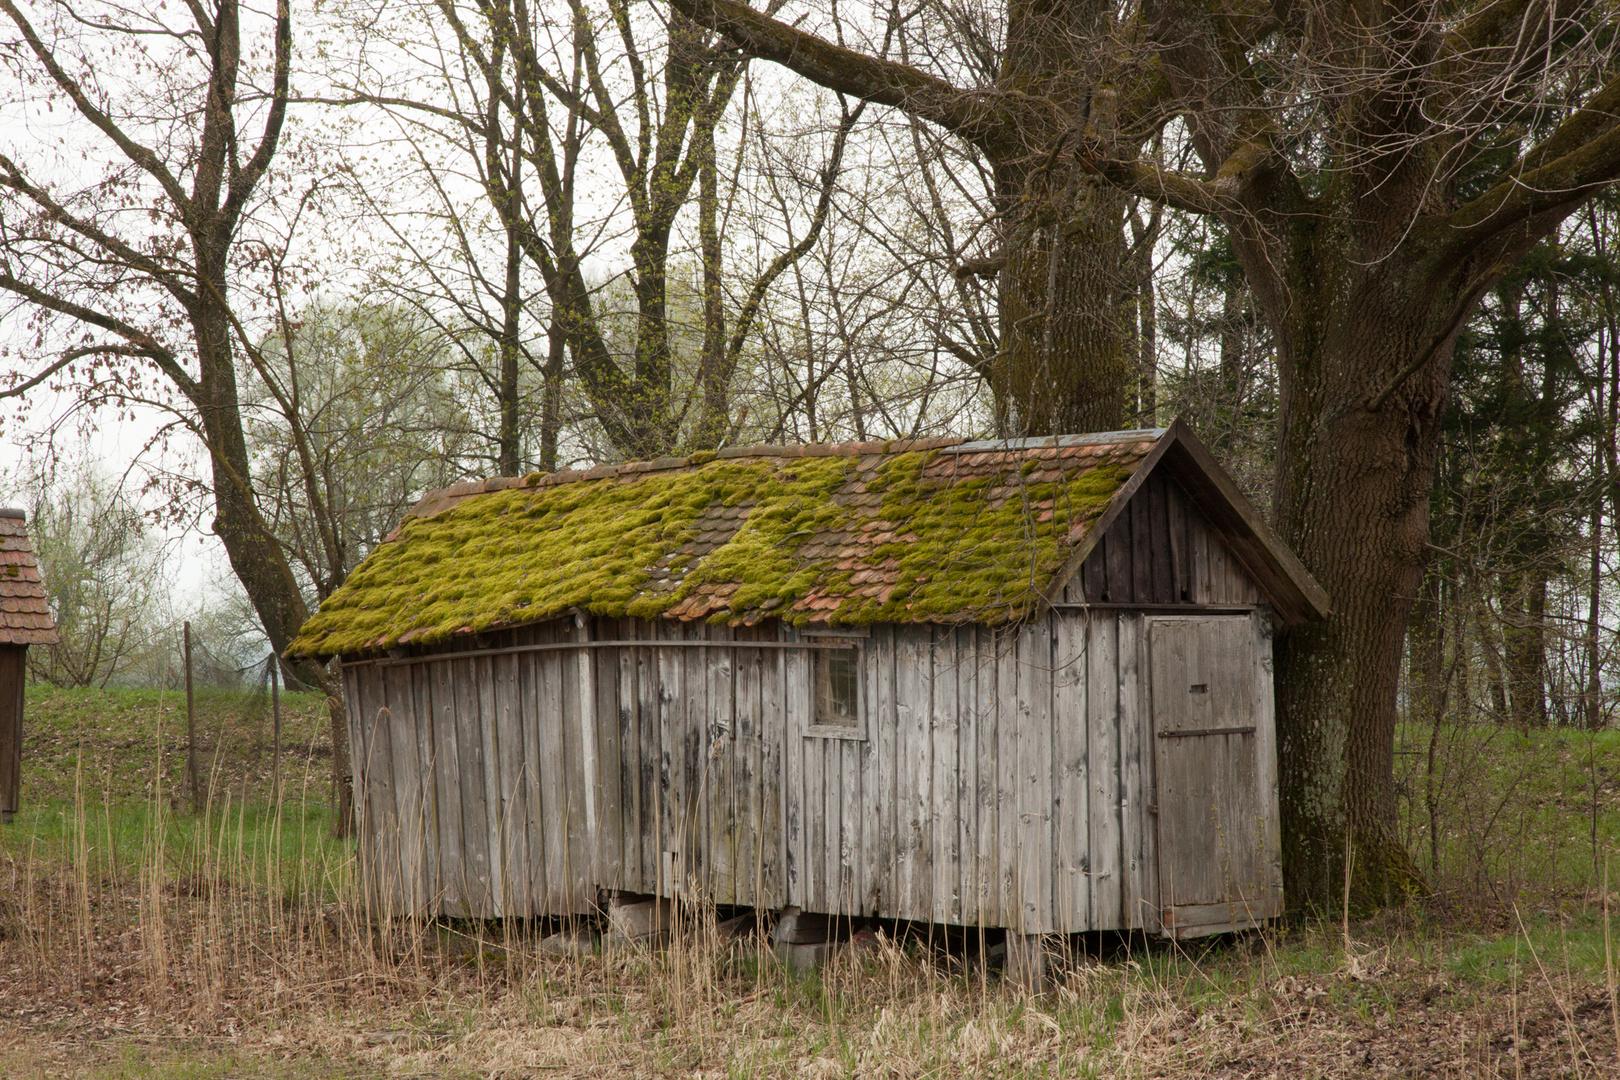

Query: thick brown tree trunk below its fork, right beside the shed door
[1273,259,1450,910]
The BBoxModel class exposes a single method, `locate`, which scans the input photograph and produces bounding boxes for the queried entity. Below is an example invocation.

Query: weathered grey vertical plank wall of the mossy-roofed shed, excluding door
[345,608,1275,933]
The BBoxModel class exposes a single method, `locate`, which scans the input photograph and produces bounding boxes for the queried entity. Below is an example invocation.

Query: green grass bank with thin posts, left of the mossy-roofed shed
[11,685,353,897]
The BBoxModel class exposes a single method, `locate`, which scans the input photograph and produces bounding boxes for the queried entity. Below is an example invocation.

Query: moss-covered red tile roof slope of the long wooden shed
[288,431,1162,656]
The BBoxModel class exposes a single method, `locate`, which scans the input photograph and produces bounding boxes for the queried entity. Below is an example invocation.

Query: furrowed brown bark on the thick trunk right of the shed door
[1273,310,1443,910]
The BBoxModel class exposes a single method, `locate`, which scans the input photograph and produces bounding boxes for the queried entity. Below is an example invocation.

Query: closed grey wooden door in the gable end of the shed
[1149,615,1281,938]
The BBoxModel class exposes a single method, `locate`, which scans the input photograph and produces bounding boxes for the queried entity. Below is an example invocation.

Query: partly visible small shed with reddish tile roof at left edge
[0,508,57,821]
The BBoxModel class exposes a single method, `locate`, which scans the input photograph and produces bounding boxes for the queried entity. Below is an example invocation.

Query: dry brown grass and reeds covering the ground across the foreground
[0,698,1620,1080]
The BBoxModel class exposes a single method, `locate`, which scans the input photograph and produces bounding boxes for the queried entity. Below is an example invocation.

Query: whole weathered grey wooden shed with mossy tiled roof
[290,423,1327,936]
